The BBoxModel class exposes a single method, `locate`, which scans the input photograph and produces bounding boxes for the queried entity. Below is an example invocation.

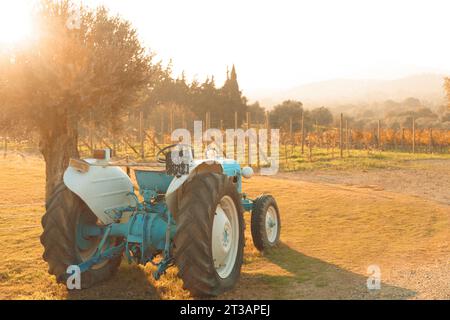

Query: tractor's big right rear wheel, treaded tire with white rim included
[174,173,245,296]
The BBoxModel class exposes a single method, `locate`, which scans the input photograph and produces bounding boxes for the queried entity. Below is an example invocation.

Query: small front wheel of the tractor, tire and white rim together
[250,195,281,251]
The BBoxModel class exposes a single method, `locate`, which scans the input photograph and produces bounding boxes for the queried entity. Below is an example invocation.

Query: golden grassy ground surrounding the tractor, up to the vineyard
[0,154,450,299]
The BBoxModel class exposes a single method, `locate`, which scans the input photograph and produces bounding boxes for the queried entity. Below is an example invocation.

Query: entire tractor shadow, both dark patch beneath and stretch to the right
[67,243,416,300]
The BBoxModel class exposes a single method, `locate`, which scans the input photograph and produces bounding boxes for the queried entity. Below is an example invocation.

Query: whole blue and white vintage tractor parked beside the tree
[41,144,281,296]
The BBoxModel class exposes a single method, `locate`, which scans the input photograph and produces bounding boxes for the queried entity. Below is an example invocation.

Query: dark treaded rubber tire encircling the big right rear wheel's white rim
[174,173,245,297]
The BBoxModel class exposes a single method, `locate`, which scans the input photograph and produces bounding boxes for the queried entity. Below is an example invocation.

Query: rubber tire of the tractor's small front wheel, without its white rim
[250,195,281,251]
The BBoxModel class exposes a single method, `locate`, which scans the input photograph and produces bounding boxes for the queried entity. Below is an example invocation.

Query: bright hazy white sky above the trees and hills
[0,0,450,93]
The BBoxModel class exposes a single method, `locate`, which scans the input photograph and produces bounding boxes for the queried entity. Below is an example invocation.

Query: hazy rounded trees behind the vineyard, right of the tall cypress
[256,78,450,131]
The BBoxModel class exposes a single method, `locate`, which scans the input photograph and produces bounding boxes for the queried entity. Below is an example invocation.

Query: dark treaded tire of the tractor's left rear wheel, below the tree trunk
[40,183,122,289]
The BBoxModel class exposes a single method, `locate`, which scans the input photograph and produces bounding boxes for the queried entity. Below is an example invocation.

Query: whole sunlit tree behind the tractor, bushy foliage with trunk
[0,0,164,198]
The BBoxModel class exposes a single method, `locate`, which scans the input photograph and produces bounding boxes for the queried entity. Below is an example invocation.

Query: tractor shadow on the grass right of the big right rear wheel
[226,243,416,299]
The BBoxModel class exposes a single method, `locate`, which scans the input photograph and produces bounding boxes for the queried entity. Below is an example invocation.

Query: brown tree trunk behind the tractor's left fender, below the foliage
[39,121,79,202]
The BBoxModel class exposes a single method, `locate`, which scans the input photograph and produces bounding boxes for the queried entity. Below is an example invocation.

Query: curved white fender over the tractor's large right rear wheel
[166,159,223,216]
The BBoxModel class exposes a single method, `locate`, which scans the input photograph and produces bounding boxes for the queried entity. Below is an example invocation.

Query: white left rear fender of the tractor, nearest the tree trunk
[63,159,133,225]
